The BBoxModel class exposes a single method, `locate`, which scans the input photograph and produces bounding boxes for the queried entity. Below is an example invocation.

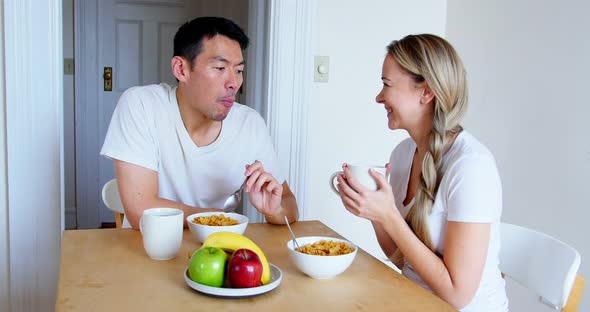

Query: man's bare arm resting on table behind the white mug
[113,160,221,230]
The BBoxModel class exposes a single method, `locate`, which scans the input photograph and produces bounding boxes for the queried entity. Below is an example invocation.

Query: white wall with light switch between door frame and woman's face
[305,0,446,266]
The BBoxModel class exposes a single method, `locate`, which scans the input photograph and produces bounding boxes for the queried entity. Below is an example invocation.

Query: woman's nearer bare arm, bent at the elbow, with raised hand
[338,163,491,309]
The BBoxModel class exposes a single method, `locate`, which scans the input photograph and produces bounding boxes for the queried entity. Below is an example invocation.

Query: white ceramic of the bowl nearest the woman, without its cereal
[287,236,358,279]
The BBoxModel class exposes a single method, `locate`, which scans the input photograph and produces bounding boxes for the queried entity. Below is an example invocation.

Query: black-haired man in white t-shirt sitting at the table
[101,17,299,229]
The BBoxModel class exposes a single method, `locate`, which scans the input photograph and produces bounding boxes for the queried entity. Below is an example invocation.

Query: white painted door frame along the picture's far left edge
[0,0,64,312]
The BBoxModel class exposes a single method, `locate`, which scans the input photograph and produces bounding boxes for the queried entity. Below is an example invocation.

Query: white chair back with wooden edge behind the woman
[500,223,585,312]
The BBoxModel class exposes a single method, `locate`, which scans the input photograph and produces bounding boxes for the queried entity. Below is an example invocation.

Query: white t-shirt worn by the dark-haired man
[100,83,284,213]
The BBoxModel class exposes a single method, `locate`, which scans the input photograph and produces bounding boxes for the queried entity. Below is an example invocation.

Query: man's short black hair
[174,16,250,66]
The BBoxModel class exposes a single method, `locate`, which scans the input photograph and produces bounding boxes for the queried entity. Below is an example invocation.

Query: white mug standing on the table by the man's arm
[139,208,184,260]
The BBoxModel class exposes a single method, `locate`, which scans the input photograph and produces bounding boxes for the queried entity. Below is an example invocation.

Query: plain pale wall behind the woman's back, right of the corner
[447,0,590,311]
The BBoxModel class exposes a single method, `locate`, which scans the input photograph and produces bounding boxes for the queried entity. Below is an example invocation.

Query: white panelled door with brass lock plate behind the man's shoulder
[98,0,197,222]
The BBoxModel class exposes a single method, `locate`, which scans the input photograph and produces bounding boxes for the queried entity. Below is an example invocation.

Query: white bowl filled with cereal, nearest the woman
[287,236,358,279]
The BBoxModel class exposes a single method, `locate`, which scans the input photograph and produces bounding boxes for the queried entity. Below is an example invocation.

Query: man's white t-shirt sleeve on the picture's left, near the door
[100,88,158,171]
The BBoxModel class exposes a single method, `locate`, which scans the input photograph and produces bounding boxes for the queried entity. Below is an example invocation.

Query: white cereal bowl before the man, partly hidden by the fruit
[186,211,248,243]
